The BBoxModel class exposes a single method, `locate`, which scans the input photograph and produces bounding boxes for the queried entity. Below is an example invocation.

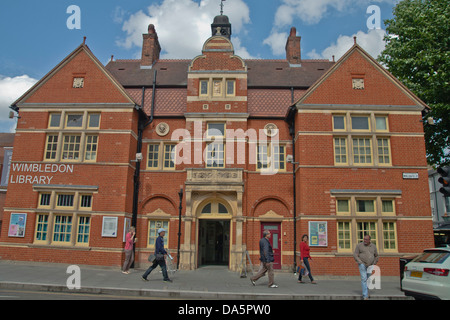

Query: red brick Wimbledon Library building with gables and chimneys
[0,16,433,275]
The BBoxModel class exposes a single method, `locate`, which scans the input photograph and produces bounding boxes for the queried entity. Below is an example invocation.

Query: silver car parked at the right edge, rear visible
[402,248,450,300]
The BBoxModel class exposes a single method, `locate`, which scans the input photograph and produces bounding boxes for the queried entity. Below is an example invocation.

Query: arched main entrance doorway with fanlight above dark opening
[198,200,231,266]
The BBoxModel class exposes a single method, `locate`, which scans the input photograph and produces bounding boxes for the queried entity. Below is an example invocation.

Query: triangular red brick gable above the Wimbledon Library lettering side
[13,44,134,105]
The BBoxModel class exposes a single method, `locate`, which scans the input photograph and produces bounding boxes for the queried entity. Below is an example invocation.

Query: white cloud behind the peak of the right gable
[307,29,386,61]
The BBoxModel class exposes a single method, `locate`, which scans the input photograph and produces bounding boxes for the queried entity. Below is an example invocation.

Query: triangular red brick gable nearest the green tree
[298,45,426,108]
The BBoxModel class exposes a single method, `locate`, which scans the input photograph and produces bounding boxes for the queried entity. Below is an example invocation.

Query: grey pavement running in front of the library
[0,260,411,300]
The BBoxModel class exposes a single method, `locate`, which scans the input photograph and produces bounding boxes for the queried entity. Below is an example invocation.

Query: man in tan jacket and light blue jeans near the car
[353,234,378,300]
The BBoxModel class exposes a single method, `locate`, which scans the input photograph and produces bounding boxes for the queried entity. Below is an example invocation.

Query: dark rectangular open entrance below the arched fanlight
[198,219,230,265]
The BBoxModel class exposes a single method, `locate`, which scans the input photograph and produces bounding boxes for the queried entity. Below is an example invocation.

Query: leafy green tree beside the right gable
[378,0,450,165]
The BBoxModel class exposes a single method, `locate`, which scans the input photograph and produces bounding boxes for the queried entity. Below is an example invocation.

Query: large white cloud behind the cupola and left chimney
[116,0,250,58]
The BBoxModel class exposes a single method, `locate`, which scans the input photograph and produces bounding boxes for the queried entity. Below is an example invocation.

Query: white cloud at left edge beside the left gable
[0,75,37,132]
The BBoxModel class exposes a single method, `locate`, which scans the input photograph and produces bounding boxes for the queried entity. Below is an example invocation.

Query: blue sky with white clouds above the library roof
[0,0,398,132]
